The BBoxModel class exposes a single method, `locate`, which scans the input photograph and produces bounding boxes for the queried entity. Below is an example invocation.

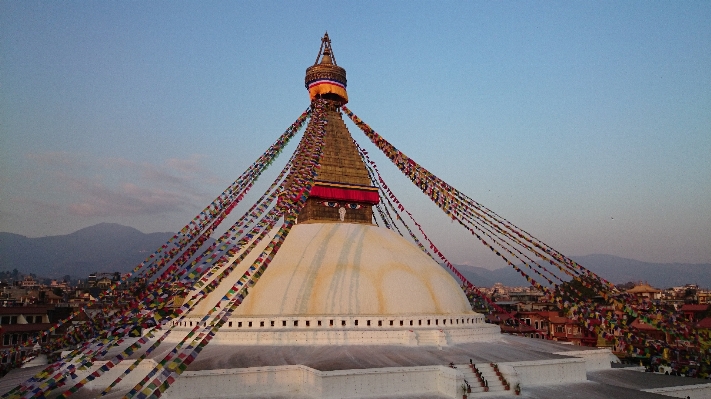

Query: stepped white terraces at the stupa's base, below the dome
[6,335,696,399]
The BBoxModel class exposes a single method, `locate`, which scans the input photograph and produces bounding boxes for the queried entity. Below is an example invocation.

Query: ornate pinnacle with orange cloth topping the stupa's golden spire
[305,32,348,105]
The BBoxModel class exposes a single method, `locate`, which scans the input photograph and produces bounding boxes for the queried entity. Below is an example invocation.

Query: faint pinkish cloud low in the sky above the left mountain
[20,152,216,217]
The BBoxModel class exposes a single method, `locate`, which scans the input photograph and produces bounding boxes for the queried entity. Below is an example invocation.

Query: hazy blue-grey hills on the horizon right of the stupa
[448,254,711,288]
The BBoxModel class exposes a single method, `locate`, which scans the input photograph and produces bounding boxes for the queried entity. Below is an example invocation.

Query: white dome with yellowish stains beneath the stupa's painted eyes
[191,223,473,317]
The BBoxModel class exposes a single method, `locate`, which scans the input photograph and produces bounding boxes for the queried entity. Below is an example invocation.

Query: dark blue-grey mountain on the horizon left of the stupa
[0,223,174,278]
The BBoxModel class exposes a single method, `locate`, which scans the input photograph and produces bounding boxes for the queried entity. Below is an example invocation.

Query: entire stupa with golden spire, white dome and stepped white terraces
[146,34,614,398]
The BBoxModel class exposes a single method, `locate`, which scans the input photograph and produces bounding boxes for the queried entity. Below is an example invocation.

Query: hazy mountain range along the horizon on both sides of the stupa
[0,223,711,288]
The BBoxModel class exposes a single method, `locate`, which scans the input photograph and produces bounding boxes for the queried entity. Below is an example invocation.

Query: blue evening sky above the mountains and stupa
[0,1,711,268]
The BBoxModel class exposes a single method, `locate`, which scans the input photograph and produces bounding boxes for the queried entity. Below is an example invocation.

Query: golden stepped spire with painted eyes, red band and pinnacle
[298,33,379,224]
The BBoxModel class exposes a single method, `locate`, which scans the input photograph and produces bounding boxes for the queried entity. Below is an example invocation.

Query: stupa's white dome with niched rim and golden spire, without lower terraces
[182,35,499,345]
